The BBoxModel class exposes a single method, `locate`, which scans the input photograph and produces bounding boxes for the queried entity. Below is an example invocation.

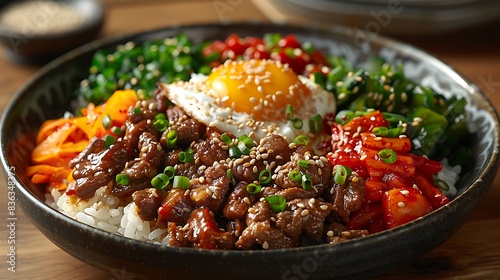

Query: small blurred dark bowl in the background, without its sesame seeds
[0,0,105,63]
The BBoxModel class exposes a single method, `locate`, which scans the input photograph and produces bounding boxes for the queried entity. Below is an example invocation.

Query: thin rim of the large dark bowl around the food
[0,22,500,257]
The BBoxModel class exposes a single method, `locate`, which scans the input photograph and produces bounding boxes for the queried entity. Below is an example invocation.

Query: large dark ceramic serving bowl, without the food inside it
[1,24,500,279]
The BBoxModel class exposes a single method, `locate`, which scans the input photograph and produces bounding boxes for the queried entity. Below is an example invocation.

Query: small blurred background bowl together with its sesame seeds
[0,0,104,63]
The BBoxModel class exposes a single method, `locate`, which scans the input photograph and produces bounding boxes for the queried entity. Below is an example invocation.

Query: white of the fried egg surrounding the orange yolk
[162,74,336,142]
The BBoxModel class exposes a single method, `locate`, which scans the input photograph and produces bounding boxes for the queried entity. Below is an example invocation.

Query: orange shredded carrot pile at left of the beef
[27,90,138,190]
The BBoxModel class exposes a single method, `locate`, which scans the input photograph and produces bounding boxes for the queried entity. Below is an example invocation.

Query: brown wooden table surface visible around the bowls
[0,0,500,280]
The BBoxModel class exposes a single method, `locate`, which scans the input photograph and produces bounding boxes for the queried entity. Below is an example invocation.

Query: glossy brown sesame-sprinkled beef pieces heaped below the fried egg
[71,90,368,250]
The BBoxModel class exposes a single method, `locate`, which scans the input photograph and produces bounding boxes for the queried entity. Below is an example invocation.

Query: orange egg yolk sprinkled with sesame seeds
[207,60,311,121]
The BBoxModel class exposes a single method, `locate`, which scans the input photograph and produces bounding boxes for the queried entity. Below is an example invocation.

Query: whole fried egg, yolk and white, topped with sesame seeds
[163,60,335,142]
